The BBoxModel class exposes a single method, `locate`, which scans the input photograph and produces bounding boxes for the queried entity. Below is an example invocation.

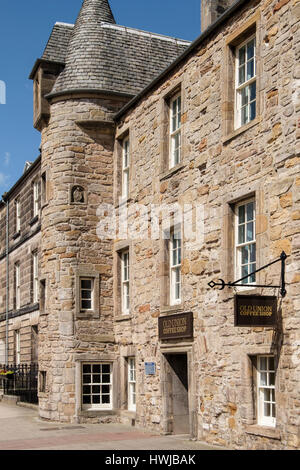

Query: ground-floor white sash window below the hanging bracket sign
[257,356,276,426]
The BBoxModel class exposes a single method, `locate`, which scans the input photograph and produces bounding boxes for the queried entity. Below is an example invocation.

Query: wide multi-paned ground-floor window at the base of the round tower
[82,363,112,409]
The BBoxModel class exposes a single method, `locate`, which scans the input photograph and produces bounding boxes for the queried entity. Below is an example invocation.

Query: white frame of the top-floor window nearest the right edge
[235,34,257,129]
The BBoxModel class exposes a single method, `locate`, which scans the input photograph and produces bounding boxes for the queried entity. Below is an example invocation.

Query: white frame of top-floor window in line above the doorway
[169,93,182,169]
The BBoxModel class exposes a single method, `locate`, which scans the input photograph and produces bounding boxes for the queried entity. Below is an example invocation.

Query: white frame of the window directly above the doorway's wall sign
[169,226,182,305]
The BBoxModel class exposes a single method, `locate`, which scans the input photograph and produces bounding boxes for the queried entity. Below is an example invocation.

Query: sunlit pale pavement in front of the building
[0,402,224,451]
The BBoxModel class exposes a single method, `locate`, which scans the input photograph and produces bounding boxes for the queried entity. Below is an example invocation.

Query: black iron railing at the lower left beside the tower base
[0,364,38,403]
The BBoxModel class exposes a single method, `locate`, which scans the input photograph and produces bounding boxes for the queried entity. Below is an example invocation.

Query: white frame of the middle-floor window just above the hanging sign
[234,198,257,286]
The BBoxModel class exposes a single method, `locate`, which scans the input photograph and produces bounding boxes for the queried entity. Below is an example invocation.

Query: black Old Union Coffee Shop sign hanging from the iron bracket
[234,295,277,326]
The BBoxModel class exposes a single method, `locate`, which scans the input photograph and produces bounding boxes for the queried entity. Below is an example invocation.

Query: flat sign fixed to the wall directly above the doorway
[158,312,194,339]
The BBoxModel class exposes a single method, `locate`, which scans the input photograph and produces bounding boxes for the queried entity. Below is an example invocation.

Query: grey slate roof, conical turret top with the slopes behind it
[43,0,190,96]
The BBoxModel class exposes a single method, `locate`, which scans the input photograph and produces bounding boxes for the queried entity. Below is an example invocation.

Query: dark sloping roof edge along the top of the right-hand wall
[114,0,249,121]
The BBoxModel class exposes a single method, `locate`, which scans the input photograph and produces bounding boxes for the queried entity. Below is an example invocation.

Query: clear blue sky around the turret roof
[0,0,200,195]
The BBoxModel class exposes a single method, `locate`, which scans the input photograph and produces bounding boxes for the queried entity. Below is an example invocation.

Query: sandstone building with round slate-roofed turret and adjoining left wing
[0,0,300,449]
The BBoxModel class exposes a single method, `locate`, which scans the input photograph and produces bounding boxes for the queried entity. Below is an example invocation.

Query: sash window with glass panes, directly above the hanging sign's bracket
[235,200,256,284]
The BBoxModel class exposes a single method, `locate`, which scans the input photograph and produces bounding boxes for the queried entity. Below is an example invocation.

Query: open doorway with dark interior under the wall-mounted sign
[164,353,190,434]
